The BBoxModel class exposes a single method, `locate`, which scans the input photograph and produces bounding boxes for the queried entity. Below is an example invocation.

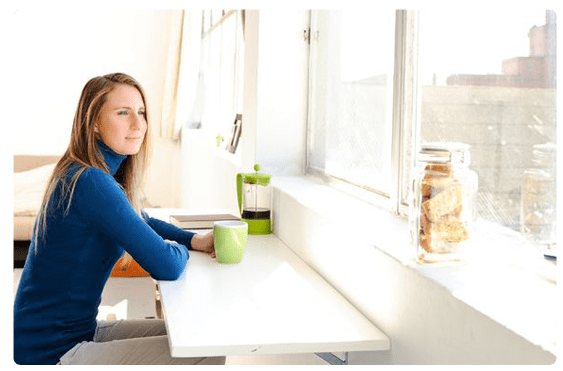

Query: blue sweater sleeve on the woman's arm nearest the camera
[71,168,189,280]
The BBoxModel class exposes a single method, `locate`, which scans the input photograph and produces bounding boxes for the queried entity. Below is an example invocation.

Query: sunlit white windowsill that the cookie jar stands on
[273,177,557,357]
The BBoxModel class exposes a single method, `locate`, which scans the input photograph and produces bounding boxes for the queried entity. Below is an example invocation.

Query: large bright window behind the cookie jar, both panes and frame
[307,9,557,244]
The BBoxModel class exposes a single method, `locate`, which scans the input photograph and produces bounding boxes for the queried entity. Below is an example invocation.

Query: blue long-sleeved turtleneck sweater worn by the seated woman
[13,142,193,365]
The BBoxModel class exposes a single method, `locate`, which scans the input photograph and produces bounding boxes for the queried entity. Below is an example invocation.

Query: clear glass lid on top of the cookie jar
[418,142,471,165]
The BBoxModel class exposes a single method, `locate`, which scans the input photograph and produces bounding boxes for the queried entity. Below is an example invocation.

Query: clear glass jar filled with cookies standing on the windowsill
[409,142,478,263]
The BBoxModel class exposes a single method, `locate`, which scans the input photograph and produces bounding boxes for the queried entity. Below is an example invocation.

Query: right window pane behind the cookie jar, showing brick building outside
[419,10,557,242]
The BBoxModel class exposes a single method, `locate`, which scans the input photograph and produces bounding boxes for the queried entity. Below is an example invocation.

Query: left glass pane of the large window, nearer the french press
[307,9,395,193]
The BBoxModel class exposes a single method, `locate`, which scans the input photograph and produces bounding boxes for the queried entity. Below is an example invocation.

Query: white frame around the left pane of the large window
[305,9,420,217]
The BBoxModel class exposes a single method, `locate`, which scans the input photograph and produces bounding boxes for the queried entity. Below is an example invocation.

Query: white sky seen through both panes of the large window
[340,9,545,83]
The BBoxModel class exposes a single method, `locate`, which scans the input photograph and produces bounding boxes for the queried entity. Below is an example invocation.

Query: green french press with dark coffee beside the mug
[237,164,272,234]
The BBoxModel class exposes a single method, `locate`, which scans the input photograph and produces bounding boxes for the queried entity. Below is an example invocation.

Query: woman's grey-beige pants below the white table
[59,319,225,365]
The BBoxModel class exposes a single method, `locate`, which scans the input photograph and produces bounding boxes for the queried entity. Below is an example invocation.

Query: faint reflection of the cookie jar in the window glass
[520,143,557,245]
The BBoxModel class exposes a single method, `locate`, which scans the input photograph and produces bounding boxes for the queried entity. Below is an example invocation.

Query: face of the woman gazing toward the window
[95,84,147,155]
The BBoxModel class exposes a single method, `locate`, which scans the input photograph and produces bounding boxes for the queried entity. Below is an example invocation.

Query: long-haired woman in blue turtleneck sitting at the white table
[13,73,225,364]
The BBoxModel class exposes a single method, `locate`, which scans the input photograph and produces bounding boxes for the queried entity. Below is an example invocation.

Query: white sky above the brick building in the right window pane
[419,9,545,83]
